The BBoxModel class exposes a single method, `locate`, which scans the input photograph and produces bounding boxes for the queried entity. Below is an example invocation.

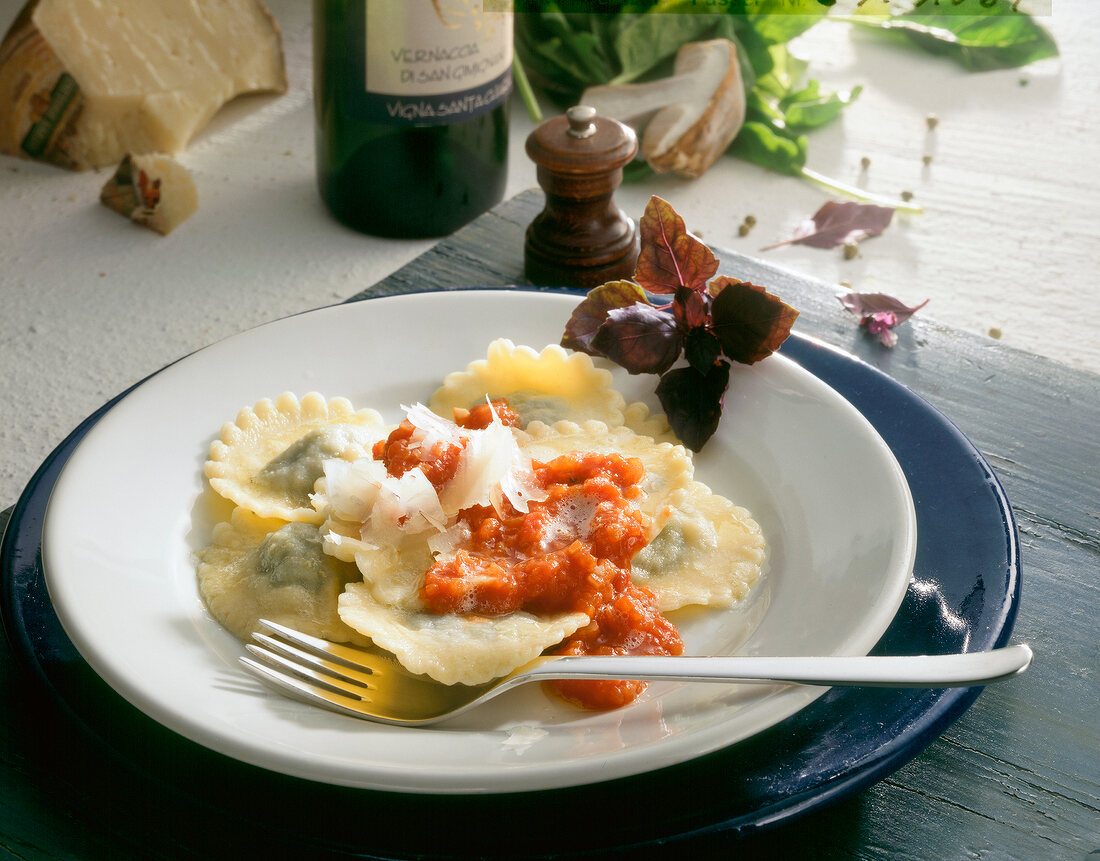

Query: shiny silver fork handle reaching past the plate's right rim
[514,643,1032,687]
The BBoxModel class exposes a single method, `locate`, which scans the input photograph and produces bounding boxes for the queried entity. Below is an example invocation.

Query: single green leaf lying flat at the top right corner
[858,2,1058,71]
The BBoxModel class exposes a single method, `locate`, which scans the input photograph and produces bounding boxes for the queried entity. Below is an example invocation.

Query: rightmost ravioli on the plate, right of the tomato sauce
[631,482,765,612]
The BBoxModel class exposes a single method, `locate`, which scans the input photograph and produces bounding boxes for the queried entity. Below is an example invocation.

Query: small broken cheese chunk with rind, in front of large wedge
[99,154,199,235]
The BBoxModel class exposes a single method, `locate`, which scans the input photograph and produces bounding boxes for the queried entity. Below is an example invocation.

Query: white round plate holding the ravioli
[43,290,916,793]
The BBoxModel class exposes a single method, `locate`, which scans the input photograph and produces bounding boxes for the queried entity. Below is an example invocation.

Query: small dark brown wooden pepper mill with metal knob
[524,106,638,288]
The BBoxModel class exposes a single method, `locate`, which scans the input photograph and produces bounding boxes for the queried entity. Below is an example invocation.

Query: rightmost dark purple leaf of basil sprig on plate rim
[711,275,799,365]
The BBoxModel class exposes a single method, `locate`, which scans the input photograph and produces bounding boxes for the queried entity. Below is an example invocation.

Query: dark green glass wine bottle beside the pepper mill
[314,0,512,238]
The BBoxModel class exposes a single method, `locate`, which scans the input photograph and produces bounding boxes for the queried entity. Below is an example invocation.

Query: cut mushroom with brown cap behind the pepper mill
[581,38,745,179]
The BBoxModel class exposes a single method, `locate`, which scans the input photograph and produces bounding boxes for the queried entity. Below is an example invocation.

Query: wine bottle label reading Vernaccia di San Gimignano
[364,0,513,125]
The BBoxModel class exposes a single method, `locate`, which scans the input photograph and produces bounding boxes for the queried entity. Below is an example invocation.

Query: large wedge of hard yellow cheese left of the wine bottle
[0,0,287,170]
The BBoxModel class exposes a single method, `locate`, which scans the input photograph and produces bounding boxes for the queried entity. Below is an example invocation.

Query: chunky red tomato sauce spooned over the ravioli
[375,405,683,709]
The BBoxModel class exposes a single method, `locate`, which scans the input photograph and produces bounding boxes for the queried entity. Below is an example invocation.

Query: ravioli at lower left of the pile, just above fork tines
[198,507,369,644]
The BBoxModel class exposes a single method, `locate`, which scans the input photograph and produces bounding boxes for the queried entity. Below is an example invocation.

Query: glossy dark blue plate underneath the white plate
[0,288,1021,858]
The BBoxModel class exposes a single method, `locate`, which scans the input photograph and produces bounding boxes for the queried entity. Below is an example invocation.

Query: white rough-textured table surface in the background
[0,0,1100,508]
